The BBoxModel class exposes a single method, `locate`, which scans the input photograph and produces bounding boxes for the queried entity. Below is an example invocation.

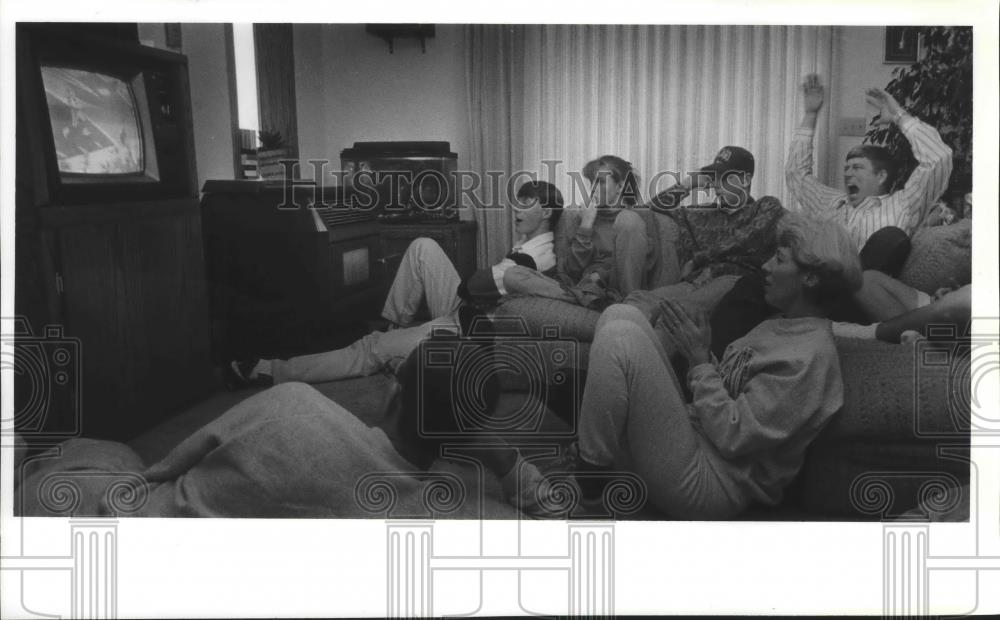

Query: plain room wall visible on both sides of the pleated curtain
[152,24,899,202]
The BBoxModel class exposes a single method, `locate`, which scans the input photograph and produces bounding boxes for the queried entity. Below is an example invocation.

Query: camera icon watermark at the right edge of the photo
[913,318,1000,441]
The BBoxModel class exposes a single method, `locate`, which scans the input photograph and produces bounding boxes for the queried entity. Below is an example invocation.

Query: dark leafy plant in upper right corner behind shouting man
[865,26,972,200]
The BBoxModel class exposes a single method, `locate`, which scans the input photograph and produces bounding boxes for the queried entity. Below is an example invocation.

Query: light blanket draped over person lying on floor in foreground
[15,383,518,519]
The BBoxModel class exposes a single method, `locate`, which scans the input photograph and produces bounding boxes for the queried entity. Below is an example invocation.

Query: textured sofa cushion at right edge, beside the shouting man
[899,219,972,294]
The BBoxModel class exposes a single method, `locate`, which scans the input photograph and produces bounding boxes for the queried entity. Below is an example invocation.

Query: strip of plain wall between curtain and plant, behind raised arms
[823,26,901,187]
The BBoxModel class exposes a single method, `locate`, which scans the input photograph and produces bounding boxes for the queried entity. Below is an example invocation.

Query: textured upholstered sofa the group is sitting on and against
[496,210,973,520]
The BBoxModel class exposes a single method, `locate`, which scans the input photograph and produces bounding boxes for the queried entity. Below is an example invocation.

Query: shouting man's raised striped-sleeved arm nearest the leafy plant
[865,88,952,234]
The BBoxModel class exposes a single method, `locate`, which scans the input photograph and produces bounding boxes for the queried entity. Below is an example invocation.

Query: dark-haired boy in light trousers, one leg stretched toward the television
[224,181,563,389]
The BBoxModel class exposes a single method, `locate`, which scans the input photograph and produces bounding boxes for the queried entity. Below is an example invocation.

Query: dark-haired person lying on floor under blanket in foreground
[19,338,564,518]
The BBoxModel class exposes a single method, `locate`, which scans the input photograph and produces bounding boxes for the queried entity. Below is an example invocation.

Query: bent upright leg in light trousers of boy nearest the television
[382,237,462,326]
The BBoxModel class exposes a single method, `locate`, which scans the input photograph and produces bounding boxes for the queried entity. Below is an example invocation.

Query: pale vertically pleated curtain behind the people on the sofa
[465,25,837,265]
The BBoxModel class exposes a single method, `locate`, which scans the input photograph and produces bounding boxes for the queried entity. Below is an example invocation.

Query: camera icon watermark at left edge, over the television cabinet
[0,317,83,444]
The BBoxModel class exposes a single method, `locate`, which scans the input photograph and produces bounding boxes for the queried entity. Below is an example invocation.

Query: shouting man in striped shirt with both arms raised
[785,74,952,260]
